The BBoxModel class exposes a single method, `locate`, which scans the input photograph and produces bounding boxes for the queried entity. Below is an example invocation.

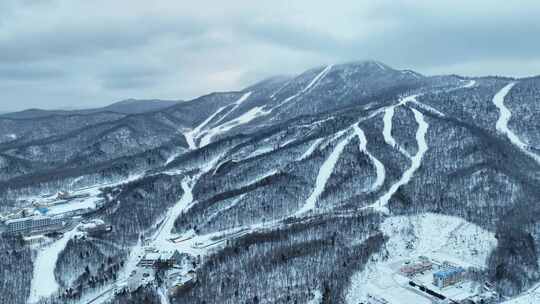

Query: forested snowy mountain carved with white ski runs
[0,61,540,304]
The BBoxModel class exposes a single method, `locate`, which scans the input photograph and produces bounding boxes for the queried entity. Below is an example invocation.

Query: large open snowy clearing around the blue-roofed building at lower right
[346,213,497,304]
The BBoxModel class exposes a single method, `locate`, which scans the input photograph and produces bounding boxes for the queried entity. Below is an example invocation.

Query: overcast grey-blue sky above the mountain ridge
[0,0,540,112]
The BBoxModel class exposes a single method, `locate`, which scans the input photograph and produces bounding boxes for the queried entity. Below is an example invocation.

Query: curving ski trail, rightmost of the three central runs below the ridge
[370,109,429,213]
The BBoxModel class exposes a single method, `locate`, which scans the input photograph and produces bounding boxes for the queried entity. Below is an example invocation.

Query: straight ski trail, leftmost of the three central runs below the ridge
[295,132,352,216]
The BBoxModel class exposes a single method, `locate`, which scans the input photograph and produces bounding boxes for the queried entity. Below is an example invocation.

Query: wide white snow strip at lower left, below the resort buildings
[28,227,81,303]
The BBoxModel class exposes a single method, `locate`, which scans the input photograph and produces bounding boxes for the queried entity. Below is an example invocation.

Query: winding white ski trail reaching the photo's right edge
[493,82,540,164]
